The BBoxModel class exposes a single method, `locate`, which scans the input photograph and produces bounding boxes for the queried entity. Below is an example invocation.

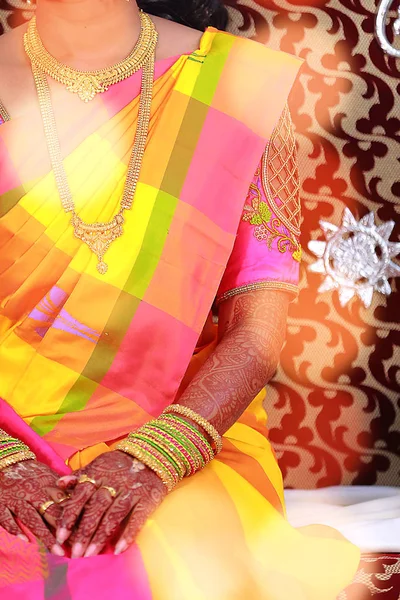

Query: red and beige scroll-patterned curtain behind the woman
[0,0,400,488]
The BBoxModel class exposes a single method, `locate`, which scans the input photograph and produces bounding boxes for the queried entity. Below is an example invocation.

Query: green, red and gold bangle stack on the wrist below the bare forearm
[117,404,222,491]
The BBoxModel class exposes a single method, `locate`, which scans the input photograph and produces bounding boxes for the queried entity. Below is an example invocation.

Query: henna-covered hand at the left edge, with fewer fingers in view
[0,460,66,556]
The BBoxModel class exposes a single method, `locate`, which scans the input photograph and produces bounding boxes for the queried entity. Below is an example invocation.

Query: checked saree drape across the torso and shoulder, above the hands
[0,28,301,458]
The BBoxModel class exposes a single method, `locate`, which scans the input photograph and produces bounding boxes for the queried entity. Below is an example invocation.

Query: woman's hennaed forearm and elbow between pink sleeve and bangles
[179,290,288,434]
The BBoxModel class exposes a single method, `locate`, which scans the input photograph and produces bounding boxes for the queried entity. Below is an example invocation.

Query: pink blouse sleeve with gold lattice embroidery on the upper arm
[217,106,301,302]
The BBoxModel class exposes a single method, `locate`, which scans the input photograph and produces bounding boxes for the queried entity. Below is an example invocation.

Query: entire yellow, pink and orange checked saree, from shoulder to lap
[0,28,358,600]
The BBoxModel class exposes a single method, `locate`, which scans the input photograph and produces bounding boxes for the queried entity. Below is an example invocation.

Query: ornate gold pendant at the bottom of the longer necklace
[71,211,124,275]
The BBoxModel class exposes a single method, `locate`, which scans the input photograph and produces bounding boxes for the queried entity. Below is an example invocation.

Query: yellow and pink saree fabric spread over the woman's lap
[0,400,359,600]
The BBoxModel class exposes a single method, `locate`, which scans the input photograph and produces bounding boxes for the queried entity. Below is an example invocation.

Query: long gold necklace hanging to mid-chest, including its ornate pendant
[27,16,155,275]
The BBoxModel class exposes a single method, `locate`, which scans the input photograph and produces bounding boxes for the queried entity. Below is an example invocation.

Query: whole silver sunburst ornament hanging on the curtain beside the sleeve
[308,208,400,308]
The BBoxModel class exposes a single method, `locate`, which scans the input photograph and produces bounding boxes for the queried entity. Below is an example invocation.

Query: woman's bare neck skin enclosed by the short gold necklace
[35,0,140,71]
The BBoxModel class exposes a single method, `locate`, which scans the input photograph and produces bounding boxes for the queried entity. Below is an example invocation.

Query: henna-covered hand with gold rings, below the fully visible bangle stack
[57,450,167,558]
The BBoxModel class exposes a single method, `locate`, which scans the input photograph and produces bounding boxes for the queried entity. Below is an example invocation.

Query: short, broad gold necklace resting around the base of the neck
[24,11,157,102]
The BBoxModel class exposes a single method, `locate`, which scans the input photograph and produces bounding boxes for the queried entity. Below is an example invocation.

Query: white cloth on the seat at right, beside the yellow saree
[285,486,400,552]
